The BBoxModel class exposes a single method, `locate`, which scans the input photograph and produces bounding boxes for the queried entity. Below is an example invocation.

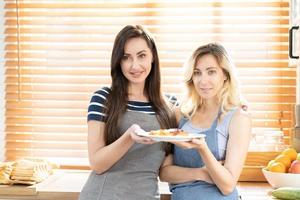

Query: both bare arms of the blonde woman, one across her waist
[160,110,251,195]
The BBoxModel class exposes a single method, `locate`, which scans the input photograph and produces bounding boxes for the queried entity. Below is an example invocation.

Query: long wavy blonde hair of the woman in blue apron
[180,43,246,117]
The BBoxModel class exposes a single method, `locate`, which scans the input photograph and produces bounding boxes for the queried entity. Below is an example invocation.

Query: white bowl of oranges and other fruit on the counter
[262,148,300,188]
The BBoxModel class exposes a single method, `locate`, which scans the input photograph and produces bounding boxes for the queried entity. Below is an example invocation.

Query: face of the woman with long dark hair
[121,38,153,84]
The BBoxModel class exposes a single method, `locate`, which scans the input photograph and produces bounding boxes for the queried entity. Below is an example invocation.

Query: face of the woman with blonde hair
[192,54,227,100]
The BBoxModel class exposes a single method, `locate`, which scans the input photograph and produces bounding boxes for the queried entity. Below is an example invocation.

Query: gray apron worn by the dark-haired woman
[79,111,165,200]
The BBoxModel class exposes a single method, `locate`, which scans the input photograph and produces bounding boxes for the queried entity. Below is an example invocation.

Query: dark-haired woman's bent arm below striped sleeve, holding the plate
[88,120,153,174]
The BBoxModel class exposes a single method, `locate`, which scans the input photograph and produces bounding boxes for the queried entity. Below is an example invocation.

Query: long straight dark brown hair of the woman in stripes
[104,25,177,145]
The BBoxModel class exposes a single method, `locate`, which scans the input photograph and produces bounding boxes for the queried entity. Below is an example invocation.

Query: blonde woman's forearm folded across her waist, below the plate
[159,154,212,184]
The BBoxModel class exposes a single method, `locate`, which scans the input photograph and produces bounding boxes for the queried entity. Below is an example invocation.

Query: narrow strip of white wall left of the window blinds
[0,0,4,161]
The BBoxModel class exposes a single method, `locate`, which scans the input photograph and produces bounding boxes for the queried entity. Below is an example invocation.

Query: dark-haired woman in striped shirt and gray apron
[79,25,177,200]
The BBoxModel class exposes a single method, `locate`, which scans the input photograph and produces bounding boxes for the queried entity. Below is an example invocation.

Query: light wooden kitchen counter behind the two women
[0,170,272,200]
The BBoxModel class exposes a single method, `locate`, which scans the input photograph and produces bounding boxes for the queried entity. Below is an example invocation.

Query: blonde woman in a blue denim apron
[160,43,251,200]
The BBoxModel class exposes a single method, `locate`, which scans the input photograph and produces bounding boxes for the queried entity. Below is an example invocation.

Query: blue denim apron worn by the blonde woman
[170,117,238,200]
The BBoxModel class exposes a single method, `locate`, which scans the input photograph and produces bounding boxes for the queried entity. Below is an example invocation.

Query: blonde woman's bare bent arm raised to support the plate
[195,109,251,195]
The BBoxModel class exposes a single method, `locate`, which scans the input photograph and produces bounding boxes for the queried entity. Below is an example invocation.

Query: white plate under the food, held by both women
[136,131,205,142]
